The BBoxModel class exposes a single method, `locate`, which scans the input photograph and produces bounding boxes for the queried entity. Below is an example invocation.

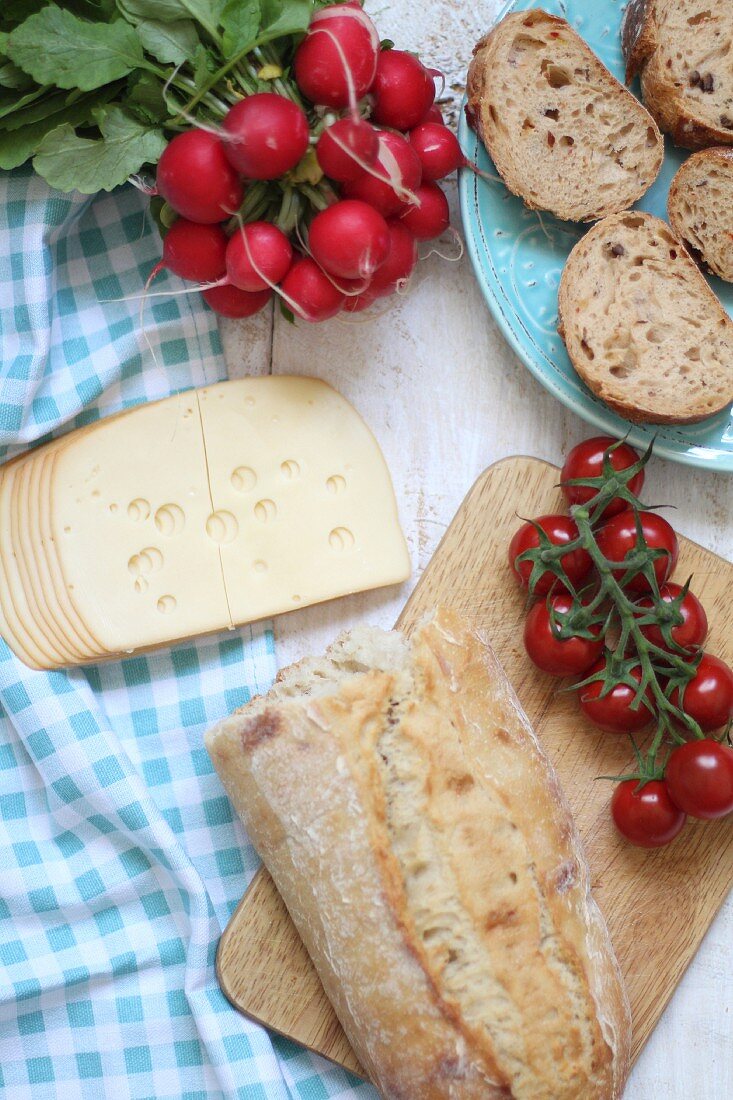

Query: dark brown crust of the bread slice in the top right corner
[621,0,733,150]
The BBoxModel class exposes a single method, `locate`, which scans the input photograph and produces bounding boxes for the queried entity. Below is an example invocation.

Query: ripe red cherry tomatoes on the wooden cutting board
[508,437,733,847]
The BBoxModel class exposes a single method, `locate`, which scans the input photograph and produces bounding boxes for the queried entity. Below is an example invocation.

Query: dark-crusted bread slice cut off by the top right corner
[621,0,733,149]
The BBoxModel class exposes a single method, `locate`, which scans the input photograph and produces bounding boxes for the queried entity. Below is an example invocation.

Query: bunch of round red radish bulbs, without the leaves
[150,2,466,321]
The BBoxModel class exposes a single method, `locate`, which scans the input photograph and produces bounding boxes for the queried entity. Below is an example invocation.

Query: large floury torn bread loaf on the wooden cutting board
[207,611,630,1100]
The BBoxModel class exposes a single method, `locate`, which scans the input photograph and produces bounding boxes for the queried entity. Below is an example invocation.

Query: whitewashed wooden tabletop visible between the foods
[222,0,733,1100]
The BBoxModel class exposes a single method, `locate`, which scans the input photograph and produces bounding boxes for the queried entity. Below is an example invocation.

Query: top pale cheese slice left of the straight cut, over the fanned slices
[51,393,229,653]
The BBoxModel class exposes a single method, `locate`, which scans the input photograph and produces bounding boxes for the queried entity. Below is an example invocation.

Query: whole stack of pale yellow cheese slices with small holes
[0,377,409,669]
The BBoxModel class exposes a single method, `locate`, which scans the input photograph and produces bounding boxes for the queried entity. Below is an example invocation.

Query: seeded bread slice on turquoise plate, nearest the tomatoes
[558,210,733,424]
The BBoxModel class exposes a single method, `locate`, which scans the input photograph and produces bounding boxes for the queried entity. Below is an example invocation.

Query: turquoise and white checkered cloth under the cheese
[0,172,374,1100]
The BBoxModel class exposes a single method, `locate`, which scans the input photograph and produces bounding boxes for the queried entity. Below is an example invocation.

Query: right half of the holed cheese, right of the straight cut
[198,376,409,623]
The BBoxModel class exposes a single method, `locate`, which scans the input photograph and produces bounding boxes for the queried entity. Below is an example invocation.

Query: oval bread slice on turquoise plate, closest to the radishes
[467,9,664,221]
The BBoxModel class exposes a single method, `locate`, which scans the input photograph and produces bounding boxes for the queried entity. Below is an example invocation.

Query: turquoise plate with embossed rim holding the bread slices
[459,0,733,473]
